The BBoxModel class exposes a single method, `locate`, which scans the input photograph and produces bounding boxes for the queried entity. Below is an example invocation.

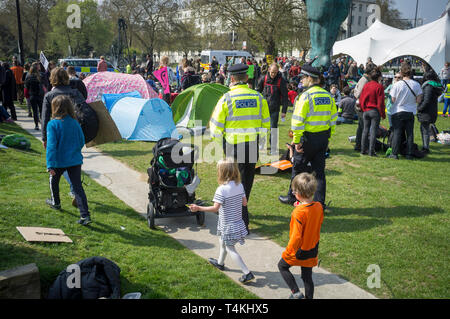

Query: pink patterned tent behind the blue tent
[83,72,158,103]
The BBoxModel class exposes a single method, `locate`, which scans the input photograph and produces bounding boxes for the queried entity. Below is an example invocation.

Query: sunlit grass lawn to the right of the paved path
[99,105,450,298]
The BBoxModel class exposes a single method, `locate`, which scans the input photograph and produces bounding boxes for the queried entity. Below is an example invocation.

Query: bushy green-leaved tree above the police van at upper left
[48,0,112,56]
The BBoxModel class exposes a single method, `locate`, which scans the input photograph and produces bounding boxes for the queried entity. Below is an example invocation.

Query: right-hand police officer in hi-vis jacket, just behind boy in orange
[279,64,337,209]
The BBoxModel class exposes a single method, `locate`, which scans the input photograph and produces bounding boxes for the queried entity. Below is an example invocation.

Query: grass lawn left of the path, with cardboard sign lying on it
[0,124,257,299]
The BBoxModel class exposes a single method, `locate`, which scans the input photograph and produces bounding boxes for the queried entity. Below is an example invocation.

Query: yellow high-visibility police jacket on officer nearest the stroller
[209,84,270,144]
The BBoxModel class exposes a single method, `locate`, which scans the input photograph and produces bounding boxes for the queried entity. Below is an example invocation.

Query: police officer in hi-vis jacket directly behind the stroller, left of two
[209,64,270,231]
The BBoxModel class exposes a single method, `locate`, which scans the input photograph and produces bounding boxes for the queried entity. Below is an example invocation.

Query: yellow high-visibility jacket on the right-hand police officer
[291,85,338,144]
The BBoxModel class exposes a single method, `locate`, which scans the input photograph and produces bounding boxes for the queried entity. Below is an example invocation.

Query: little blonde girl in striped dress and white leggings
[189,158,255,283]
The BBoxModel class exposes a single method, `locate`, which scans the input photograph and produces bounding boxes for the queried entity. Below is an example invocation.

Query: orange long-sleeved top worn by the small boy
[281,202,323,267]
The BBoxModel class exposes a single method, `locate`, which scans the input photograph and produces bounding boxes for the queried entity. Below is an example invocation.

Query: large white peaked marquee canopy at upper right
[333,12,450,73]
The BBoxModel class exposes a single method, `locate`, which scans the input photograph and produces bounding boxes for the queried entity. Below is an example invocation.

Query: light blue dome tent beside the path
[111,97,178,141]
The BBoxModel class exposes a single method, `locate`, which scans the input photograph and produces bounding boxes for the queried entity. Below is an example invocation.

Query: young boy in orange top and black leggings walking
[278,173,323,299]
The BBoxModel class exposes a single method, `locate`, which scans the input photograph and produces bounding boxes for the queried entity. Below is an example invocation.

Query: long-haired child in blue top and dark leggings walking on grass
[46,95,91,226]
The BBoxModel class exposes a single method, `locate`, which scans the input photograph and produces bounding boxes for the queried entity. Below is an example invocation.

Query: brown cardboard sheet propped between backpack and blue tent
[86,101,122,147]
